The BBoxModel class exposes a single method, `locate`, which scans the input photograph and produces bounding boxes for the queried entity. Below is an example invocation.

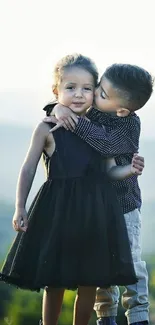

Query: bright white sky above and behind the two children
[0,0,155,139]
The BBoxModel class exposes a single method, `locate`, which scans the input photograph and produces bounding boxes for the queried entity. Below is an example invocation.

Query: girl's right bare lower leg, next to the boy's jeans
[73,287,96,325]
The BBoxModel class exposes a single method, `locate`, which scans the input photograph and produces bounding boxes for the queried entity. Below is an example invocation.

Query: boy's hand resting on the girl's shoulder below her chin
[43,104,78,132]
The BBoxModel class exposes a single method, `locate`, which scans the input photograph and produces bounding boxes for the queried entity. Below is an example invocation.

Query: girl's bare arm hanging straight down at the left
[13,123,52,231]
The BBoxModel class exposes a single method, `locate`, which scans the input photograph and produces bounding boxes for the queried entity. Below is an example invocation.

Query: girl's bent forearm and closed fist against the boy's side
[107,154,144,181]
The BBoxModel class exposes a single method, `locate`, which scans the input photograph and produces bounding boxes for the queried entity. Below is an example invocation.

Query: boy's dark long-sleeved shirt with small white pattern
[75,108,141,213]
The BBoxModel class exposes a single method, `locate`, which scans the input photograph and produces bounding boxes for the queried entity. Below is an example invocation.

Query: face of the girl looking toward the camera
[56,67,95,115]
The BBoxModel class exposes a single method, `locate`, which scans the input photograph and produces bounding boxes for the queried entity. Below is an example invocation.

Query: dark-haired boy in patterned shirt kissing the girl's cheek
[44,64,153,325]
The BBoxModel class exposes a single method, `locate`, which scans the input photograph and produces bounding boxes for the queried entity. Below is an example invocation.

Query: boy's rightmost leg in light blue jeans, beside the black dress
[122,210,149,324]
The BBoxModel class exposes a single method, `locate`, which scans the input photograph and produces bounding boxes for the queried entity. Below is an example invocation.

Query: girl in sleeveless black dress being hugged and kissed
[1,55,137,325]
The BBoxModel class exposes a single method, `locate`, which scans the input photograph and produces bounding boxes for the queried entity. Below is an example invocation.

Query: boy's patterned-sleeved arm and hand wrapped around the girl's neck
[44,104,140,157]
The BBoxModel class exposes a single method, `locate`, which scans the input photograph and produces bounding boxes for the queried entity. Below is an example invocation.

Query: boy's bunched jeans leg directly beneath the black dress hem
[94,286,120,318]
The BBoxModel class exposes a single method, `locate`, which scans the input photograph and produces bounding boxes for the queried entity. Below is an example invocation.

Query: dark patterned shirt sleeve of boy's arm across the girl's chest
[74,115,140,157]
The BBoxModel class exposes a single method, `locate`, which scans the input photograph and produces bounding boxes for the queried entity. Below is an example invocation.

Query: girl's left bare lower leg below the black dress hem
[42,287,65,325]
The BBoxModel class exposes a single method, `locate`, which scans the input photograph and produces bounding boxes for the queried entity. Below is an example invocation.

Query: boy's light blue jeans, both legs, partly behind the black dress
[94,209,149,324]
